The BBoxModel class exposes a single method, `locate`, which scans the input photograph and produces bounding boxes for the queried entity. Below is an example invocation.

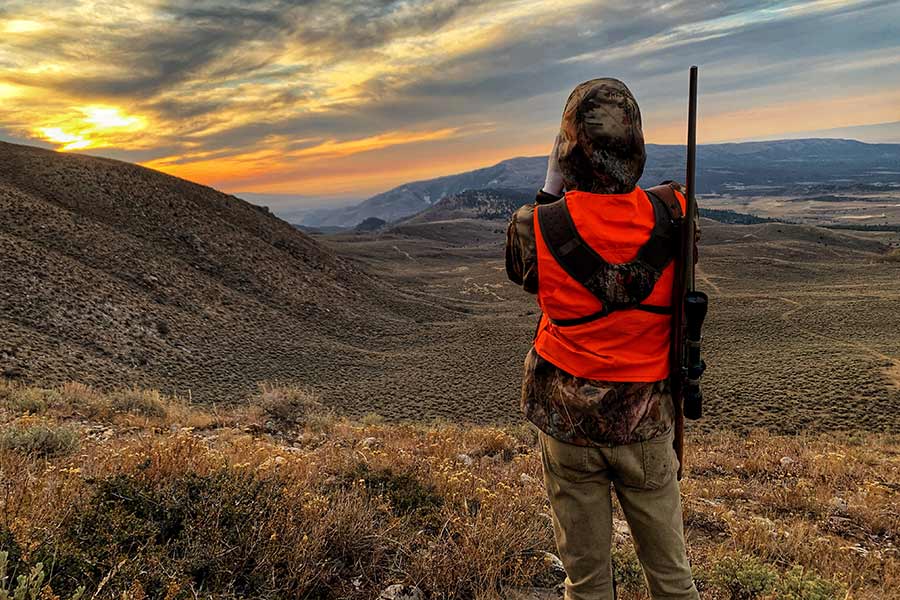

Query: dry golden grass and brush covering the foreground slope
[0,384,900,600]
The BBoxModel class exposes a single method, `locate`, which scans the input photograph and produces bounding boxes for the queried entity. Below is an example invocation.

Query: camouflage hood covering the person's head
[557,78,647,194]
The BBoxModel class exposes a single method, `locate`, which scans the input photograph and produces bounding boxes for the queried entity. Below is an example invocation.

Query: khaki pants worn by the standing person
[540,433,699,600]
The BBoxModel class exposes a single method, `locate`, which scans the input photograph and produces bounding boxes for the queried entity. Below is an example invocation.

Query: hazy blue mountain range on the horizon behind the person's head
[302,139,900,227]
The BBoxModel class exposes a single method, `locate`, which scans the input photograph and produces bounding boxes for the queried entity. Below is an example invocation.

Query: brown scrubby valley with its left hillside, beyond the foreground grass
[0,138,900,433]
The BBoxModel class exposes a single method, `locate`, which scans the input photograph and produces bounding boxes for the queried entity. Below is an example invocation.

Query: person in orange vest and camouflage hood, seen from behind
[506,79,699,600]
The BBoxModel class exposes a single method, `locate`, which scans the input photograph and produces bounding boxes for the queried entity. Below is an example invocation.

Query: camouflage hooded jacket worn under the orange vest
[506,79,674,446]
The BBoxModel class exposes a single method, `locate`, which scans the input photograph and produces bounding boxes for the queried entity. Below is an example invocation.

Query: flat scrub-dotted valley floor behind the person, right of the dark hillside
[320,221,900,433]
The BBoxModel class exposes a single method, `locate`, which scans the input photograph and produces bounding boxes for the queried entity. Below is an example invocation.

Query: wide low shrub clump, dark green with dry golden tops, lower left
[43,465,394,598]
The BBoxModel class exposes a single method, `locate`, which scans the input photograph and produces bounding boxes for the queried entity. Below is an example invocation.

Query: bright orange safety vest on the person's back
[534,187,685,382]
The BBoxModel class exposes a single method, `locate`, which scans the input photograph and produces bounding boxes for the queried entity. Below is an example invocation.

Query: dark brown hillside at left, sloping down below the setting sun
[0,143,443,400]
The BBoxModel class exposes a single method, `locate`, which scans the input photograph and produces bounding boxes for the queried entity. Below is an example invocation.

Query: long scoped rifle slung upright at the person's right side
[670,67,709,480]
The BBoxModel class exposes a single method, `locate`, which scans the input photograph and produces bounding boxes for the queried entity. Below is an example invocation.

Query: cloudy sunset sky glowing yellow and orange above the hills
[0,0,900,203]
